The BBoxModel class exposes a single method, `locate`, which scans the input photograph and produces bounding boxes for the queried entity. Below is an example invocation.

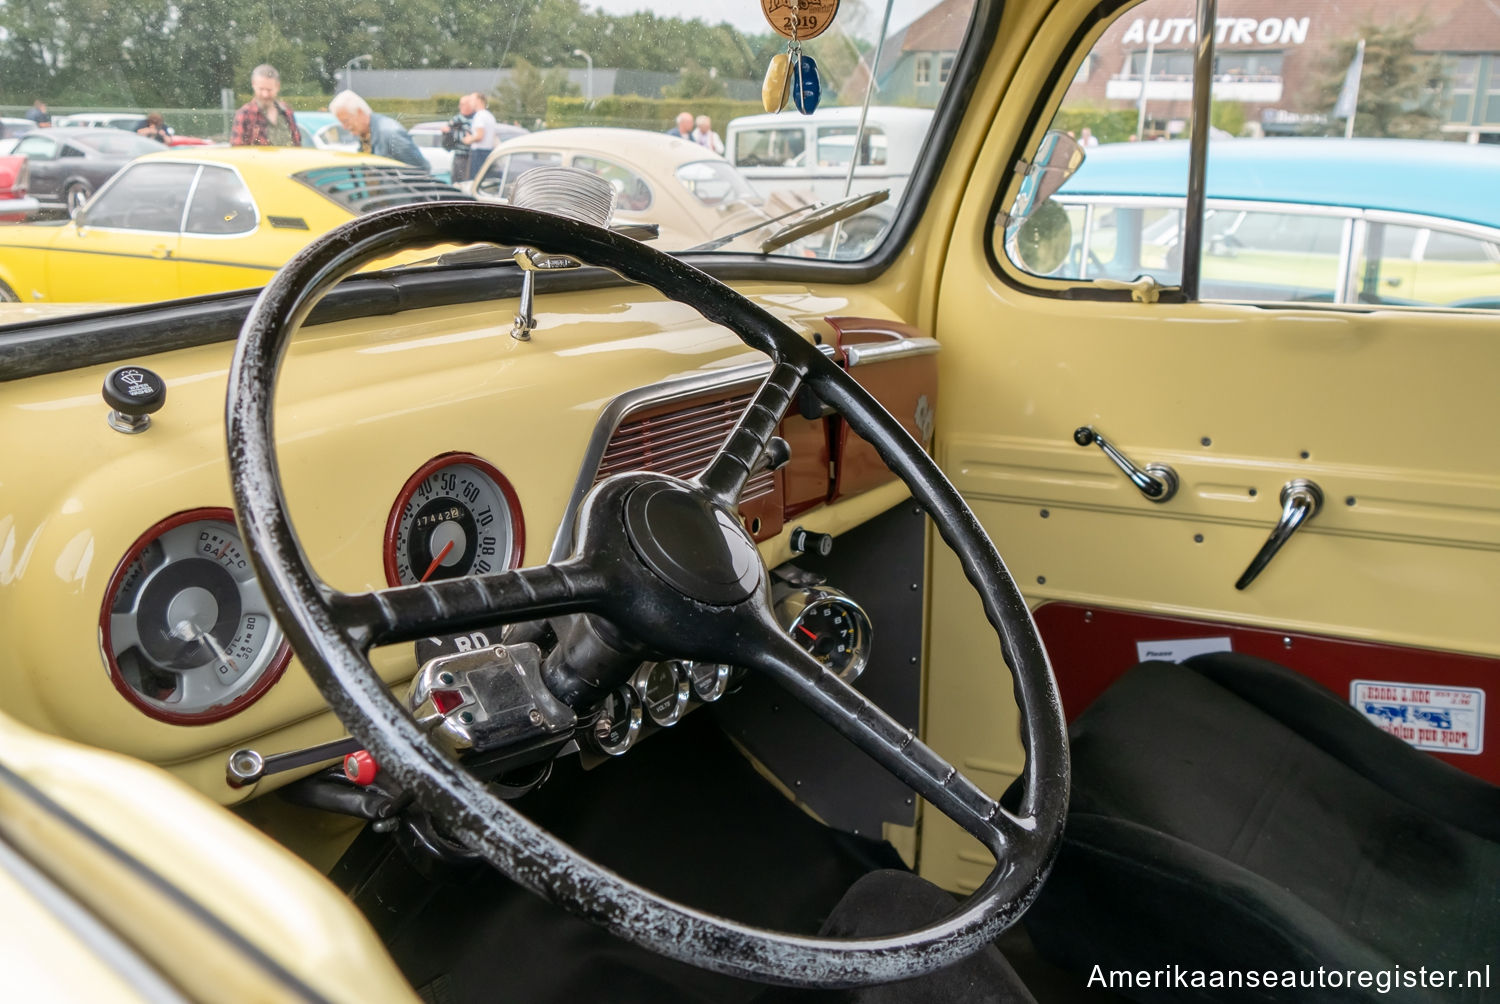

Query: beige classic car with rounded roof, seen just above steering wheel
[465,128,770,251]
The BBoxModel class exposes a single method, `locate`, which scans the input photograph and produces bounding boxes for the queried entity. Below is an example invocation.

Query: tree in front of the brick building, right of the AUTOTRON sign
[1314,15,1443,140]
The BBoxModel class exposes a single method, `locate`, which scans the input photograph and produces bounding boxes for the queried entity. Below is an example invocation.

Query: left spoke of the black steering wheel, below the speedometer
[327,560,605,651]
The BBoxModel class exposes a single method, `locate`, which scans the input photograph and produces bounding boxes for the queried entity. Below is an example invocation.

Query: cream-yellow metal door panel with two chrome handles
[921,107,1500,888]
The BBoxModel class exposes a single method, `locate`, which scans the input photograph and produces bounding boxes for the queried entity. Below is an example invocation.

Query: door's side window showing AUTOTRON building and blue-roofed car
[992,0,1500,309]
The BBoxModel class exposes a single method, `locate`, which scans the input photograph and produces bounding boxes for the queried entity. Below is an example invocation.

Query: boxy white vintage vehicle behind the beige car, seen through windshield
[725,107,933,206]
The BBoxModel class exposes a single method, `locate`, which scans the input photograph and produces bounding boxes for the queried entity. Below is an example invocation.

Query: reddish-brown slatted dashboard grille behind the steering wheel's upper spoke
[594,393,776,507]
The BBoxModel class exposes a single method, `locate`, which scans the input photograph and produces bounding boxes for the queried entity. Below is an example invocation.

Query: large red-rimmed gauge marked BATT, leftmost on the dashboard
[99,509,291,723]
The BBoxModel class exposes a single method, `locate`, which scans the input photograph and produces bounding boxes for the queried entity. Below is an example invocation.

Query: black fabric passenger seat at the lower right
[1026,653,1500,1004]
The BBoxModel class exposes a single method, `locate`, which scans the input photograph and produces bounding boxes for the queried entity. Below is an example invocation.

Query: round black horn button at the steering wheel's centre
[626,482,761,606]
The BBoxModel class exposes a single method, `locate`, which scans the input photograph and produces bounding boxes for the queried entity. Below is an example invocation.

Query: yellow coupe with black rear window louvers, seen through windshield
[0,147,464,303]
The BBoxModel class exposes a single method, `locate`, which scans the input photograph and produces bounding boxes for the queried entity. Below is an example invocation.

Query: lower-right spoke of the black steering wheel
[750,630,1029,857]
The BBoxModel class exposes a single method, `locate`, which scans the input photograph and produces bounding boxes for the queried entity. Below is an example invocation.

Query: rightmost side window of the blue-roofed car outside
[1355,222,1500,309]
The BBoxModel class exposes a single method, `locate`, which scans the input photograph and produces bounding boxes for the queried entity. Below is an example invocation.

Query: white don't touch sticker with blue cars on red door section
[1349,680,1485,753]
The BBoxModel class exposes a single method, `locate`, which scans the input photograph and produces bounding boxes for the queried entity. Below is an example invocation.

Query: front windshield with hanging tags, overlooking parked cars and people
[0,0,974,306]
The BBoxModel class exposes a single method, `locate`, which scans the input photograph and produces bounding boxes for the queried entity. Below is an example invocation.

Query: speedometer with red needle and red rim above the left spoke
[386,453,524,585]
